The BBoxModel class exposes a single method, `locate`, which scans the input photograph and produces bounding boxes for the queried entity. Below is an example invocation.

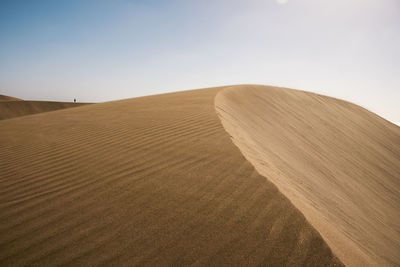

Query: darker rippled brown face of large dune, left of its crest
[0,88,341,266]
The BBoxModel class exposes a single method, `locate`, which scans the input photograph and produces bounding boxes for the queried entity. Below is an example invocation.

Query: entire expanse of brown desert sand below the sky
[0,85,400,266]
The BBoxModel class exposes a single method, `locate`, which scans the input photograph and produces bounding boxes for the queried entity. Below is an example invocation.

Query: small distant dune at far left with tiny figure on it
[0,95,86,120]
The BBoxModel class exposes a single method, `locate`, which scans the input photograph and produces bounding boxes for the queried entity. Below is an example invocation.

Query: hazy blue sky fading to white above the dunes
[0,0,400,124]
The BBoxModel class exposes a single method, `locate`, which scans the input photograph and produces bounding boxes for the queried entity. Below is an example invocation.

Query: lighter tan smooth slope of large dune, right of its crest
[216,85,400,266]
